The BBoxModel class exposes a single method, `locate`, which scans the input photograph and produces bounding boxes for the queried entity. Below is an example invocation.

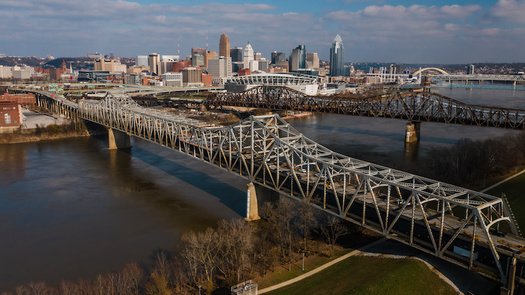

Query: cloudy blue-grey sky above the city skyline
[0,0,525,64]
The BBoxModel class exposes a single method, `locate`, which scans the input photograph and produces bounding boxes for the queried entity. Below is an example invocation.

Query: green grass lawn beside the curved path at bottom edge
[259,256,457,295]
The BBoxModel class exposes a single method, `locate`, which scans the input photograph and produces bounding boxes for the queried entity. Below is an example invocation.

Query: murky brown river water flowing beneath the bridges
[0,88,525,291]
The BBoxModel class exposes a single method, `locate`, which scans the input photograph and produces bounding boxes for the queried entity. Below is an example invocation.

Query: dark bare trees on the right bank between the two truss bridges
[415,132,525,186]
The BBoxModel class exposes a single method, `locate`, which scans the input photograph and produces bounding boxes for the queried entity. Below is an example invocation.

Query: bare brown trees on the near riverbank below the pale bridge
[2,198,360,295]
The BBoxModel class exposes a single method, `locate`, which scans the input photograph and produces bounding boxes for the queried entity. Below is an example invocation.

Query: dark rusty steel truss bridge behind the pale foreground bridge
[205,86,525,129]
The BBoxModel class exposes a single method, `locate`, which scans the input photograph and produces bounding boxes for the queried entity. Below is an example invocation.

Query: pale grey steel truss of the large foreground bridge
[79,95,517,280]
